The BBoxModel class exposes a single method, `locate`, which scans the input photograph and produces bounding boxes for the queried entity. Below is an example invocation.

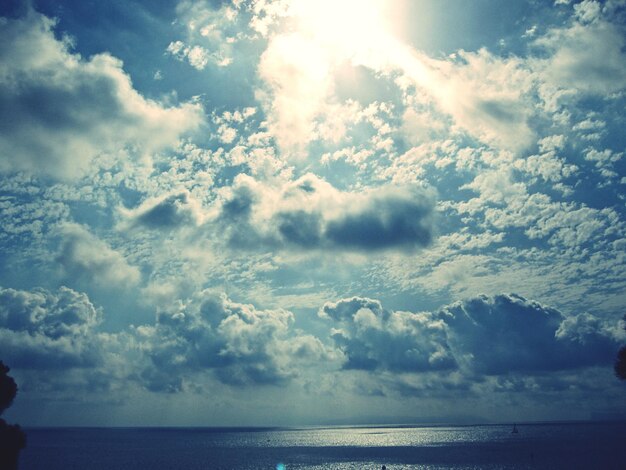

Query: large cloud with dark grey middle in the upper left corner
[0,11,202,178]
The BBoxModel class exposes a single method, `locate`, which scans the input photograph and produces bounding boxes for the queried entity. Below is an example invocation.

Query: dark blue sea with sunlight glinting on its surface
[20,422,626,470]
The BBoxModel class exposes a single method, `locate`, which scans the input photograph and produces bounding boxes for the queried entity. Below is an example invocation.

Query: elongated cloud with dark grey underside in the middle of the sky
[218,174,434,250]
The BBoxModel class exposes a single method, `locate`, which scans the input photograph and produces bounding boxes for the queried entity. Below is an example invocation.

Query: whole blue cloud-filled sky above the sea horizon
[0,0,626,426]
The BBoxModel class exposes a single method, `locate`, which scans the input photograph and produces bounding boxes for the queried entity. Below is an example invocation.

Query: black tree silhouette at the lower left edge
[0,361,26,470]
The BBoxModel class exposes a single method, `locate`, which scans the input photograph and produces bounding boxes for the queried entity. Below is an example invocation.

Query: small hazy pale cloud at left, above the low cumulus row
[57,223,141,288]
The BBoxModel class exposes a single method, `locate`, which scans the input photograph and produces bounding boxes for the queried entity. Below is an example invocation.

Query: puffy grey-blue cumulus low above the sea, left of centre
[137,291,329,392]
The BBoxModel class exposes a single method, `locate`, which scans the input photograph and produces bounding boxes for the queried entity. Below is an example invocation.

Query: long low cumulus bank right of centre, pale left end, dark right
[320,294,618,376]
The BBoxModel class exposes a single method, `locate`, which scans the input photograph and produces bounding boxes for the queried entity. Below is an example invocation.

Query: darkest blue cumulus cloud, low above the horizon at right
[437,294,615,375]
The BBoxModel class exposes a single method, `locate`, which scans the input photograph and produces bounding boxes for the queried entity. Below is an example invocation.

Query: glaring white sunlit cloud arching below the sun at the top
[259,1,534,154]
